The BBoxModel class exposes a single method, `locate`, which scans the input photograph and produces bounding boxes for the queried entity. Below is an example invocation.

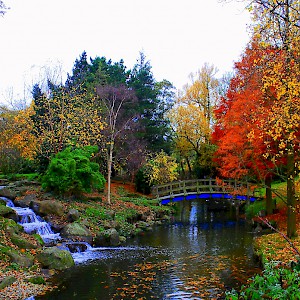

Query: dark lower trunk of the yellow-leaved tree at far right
[287,151,296,238]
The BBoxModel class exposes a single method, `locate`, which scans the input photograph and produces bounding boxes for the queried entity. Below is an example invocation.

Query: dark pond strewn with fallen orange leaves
[35,200,259,300]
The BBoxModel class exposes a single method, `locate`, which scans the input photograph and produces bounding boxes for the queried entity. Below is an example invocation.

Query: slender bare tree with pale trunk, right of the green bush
[97,85,136,204]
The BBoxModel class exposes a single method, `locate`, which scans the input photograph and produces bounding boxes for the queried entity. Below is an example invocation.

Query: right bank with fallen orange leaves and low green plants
[226,182,300,300]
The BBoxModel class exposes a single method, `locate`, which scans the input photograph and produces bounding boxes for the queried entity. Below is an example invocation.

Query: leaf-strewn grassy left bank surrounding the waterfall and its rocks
[0,182,172,300]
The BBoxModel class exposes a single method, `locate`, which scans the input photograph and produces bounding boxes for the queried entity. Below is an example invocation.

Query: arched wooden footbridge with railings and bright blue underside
[152,179,258,204]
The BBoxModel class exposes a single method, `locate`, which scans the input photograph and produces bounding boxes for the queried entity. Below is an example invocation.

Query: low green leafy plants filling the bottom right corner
[226,262,300,300]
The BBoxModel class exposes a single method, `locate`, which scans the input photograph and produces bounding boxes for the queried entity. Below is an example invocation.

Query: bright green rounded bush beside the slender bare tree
[41,146,105,194]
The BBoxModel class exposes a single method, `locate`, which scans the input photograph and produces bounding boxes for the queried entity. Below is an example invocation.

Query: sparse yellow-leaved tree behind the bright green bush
[31,82,104,171]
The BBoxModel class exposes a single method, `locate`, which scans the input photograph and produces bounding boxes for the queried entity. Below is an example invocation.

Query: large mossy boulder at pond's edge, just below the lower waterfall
[36,247,75,270]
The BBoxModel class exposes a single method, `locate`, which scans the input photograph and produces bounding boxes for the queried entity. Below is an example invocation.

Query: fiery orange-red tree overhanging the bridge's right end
[213,41,283,214]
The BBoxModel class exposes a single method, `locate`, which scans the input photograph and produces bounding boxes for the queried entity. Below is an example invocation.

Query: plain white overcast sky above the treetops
[0,0,250,102]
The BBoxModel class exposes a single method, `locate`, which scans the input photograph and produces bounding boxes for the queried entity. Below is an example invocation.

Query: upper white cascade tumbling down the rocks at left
[1,197,61,244]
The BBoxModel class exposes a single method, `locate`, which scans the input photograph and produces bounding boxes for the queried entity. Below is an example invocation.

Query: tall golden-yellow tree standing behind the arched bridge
[170,63,219,178]
